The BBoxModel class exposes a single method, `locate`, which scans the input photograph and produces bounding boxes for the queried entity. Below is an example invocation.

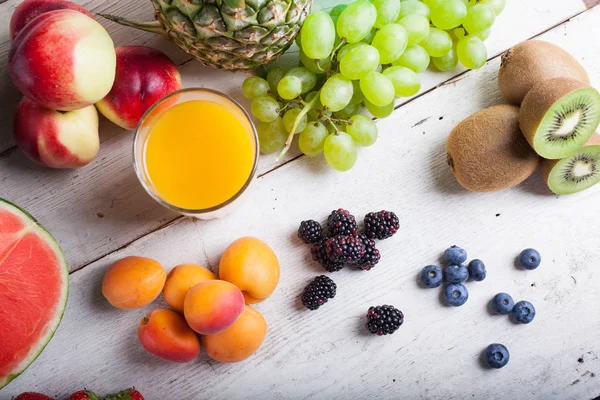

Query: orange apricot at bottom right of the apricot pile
[202,305,267,363]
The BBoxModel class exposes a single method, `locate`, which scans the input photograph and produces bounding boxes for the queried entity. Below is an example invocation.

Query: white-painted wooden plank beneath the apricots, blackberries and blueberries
[2,9,600,400]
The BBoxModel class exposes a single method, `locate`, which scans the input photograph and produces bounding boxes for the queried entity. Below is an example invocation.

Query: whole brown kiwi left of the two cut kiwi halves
[446,104,539,192]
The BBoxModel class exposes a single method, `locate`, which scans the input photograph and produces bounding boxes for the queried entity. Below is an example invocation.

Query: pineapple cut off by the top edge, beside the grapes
[101,0,312,71]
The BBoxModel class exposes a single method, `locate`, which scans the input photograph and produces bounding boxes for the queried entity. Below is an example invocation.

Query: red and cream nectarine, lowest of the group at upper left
[13,97,100,168]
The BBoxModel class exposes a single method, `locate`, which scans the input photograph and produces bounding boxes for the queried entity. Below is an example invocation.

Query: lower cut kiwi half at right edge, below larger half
[541,134,600,194]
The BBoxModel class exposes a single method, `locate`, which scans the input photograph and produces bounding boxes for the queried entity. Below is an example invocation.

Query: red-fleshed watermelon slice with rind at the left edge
[0,199,69,389]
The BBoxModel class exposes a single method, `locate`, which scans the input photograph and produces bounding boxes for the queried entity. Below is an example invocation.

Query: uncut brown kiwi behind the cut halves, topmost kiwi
[498,40,590,105]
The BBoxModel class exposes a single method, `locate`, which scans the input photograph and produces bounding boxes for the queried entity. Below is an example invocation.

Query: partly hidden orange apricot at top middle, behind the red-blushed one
[163,264,217,313]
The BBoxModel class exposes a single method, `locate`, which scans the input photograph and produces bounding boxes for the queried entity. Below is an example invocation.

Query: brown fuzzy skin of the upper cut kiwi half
[519,78,590,154]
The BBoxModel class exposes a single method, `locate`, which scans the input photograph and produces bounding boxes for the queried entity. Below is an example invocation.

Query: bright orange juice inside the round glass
[143,100,257,210]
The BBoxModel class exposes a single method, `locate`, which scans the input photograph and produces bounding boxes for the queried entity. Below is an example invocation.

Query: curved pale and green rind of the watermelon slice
[0,198,69,389]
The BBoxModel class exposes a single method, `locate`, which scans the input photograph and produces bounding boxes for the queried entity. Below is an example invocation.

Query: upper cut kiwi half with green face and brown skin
[519,78,600,160]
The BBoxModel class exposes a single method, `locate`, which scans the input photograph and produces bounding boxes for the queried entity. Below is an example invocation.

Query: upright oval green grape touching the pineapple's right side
[300,11,335,60]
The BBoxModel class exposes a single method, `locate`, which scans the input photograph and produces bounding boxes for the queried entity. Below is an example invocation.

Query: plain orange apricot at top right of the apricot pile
[219,237,279,304]
